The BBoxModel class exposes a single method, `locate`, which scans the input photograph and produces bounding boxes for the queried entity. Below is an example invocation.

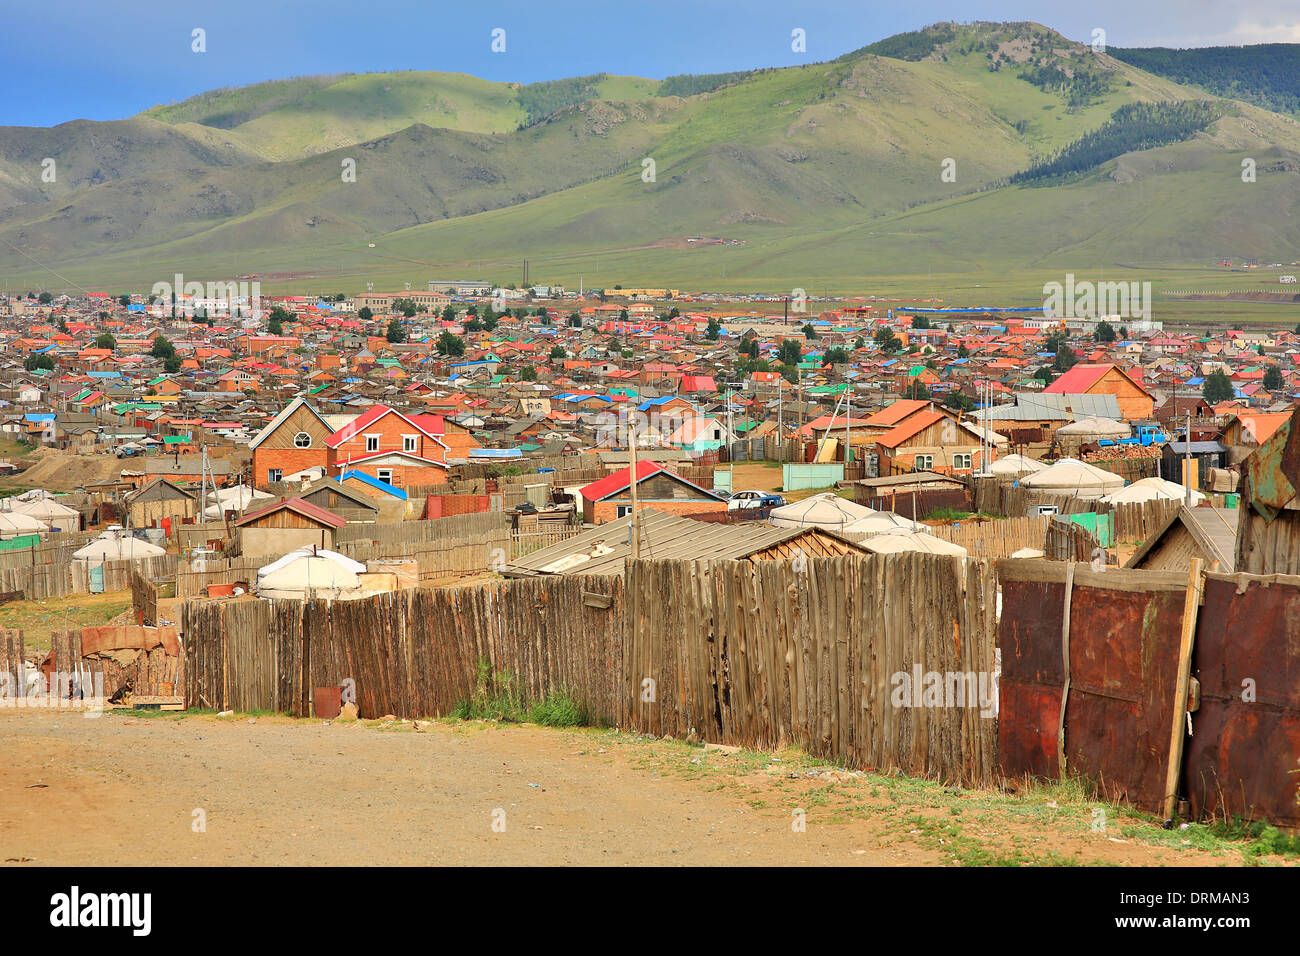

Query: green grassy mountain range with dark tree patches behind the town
[0,23,1300,291]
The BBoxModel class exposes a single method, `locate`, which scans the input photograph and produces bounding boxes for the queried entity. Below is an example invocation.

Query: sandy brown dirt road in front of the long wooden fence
[0,710,1279,866]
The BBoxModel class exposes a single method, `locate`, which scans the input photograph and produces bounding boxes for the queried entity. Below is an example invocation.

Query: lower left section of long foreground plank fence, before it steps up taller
[182,576,627,723]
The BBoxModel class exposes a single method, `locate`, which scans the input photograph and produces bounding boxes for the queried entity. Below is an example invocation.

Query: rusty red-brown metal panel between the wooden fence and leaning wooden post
[998,559,1186,813]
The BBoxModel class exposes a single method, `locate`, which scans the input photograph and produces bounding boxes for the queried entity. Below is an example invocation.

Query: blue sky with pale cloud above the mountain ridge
[0,0,1300,127]
